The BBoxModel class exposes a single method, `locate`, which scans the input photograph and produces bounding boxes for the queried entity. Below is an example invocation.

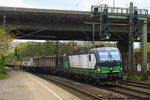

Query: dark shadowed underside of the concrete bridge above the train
[13,25,128,41]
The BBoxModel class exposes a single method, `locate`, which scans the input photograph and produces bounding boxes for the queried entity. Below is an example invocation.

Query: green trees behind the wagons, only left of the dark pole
[17,42,55,58]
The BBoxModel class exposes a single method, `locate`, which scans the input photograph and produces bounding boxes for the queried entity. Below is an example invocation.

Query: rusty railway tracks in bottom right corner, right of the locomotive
[105,82,150,100]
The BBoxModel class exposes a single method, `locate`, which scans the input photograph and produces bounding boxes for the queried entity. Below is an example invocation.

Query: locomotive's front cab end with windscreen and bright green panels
[89,47,124,82]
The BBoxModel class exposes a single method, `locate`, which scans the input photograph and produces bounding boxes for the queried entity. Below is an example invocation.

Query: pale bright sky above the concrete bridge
[0,0,143,46]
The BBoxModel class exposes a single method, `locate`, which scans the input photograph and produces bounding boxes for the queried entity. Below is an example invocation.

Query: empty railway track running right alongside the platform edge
[35,74,103,100]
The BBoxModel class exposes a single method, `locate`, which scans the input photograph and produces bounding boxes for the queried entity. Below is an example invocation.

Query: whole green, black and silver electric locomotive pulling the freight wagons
[64,47,124,83]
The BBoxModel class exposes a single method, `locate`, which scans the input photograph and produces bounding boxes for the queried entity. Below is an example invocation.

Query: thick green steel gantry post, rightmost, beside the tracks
[141,20,148,80]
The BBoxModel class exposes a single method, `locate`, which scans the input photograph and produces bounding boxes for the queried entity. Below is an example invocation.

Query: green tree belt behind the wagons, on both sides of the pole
[13,41,78,59]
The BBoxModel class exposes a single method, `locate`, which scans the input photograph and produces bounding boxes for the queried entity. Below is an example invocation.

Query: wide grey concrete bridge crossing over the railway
[0,7,150,42]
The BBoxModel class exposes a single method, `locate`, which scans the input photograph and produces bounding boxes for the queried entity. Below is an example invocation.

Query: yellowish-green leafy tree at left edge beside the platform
[0,26,15,73]
